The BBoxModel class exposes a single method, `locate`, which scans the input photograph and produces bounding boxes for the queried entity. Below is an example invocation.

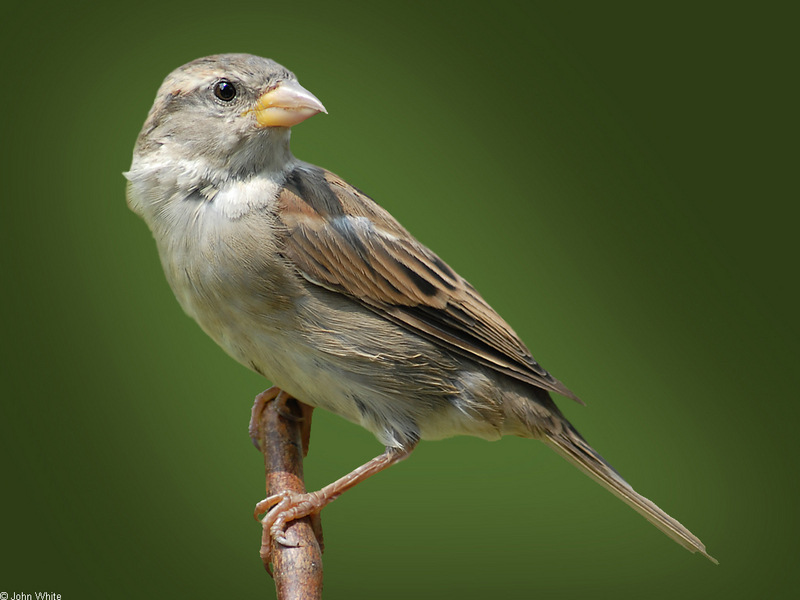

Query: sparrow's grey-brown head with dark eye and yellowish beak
[134,54,327,177]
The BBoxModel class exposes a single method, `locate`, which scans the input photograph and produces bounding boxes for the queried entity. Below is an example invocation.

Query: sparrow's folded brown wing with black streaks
[278,165,582,403]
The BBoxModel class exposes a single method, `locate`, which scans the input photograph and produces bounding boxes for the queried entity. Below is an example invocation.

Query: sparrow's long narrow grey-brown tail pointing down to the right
[541,419,719,564]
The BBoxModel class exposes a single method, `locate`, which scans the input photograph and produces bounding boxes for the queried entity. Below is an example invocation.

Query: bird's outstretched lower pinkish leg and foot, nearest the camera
[253,446,414,546]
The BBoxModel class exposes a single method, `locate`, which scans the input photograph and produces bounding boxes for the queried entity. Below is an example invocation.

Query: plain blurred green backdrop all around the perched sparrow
[0,0,800,600]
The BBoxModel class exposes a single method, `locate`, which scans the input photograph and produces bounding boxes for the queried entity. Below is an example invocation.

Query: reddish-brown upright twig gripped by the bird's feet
[253,392,322,600]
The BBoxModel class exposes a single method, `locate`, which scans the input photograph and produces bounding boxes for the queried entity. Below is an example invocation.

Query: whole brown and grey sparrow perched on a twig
[124,54,716,562]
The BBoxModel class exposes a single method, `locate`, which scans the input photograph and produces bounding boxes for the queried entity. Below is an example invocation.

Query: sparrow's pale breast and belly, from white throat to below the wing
[135,173,512,446]
